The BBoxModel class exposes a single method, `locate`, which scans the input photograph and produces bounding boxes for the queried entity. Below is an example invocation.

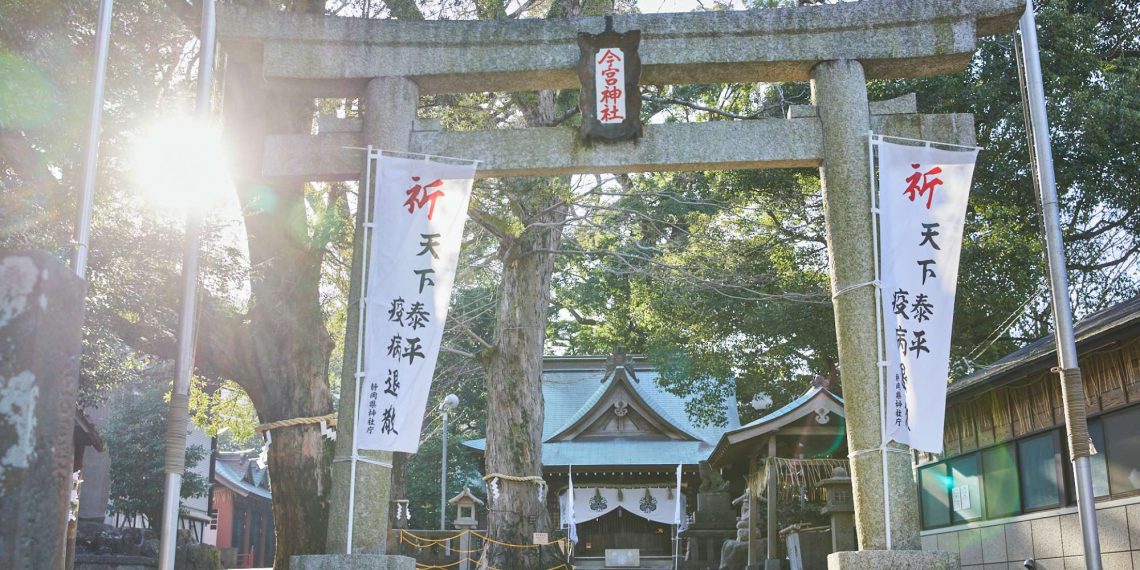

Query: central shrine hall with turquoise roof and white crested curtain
[466,352,740,563]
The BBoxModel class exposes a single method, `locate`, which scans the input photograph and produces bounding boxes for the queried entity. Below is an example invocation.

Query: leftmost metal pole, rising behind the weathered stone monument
[72,0,114,279]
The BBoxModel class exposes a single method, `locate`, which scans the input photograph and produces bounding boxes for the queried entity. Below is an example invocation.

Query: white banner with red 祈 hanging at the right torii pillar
[876,141,978,453]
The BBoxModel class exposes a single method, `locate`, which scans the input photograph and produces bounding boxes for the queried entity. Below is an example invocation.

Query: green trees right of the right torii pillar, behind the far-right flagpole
[870,0,1140,375]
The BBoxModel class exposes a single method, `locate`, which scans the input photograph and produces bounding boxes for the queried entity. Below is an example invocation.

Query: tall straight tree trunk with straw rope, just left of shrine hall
[485,175,569,570]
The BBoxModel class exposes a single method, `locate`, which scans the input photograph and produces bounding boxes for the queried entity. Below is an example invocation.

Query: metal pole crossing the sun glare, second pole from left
[158,0,214,570]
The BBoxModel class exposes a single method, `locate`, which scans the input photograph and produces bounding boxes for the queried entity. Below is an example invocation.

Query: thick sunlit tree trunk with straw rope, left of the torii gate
[226,58,333,569]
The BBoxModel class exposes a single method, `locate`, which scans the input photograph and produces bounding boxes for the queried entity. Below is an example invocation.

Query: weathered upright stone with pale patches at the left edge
[0,252,84,568]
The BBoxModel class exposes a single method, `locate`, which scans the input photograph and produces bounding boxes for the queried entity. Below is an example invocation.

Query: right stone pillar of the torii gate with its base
[812,59,958,570]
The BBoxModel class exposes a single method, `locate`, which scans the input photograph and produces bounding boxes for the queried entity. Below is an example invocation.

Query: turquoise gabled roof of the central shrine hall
[465,357,740,467]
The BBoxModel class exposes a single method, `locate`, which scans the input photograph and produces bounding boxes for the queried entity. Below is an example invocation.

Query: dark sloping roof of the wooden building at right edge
[948,296,1140,397]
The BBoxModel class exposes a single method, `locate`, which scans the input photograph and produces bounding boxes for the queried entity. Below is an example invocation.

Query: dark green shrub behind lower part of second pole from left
[103,374,209,528]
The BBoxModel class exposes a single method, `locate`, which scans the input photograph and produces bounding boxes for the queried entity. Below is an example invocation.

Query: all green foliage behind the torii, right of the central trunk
[549,0,1140,421]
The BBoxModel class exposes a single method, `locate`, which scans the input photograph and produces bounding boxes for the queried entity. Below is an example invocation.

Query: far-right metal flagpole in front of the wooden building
[1018,0,1101,570]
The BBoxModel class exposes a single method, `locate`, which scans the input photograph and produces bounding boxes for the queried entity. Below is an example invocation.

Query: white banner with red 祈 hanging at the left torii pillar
[356,155,475,453]
